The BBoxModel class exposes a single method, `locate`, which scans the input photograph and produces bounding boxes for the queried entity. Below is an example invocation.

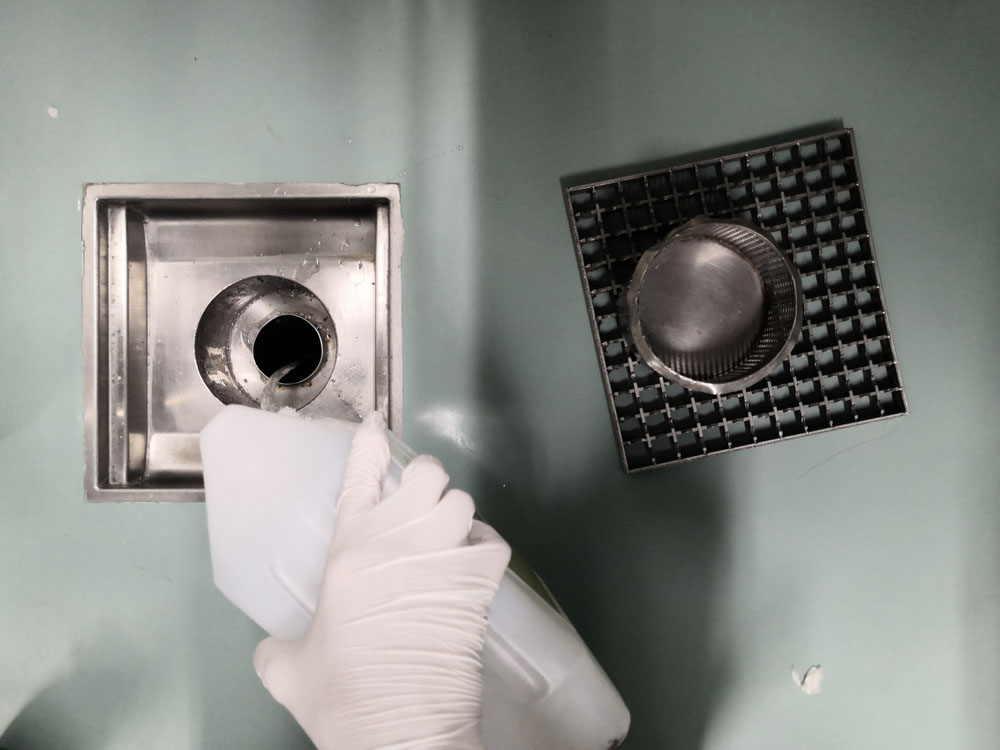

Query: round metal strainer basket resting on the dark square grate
[626,217,802,394]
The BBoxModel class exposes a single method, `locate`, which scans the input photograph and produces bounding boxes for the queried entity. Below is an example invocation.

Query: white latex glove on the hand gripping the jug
[254,415,510,750]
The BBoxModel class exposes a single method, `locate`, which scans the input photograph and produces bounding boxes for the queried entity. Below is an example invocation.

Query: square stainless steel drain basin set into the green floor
[83,184,403,502]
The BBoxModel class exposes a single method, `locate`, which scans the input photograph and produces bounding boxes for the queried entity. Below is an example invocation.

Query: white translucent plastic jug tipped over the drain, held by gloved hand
[201,406,629,750]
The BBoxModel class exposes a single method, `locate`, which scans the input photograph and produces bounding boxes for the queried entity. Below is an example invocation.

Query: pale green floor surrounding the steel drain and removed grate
[0,0,1000,750]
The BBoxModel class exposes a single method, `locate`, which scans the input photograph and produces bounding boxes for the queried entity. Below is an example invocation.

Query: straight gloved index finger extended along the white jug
[336,412,389,536]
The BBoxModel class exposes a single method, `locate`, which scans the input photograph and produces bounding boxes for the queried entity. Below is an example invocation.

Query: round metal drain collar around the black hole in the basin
[194,276,337,409]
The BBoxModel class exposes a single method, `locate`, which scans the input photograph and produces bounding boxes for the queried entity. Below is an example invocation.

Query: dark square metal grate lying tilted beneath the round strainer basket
[565,129,907,472]
